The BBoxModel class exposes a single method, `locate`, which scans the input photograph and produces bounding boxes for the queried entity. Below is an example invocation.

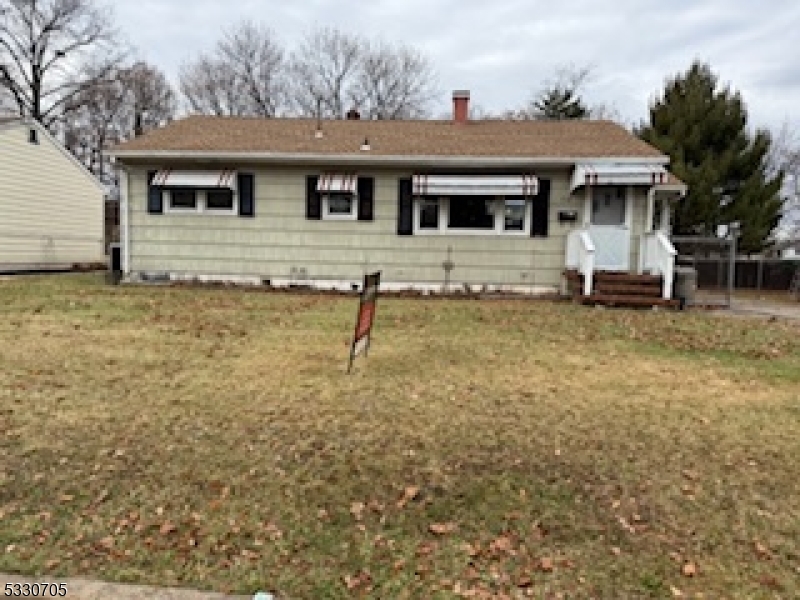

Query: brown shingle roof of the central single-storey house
[115,116,663,159]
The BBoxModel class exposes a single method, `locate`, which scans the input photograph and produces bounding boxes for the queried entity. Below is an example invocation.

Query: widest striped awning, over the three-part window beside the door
[412,175,539,196]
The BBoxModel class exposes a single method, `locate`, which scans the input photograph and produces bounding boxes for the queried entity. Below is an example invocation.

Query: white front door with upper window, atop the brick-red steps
[590,185,631,271]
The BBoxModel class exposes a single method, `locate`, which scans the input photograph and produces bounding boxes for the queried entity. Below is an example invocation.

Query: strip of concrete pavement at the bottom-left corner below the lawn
[0,573,252,600]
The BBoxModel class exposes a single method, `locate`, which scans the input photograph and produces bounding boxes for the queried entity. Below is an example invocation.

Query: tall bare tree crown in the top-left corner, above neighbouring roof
[0,0,122,127]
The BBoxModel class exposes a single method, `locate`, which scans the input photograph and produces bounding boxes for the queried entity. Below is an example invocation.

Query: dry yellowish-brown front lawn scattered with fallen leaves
[0,275,800,598]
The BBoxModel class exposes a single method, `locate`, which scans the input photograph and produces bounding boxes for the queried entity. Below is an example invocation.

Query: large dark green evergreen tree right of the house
[638,62,783,252]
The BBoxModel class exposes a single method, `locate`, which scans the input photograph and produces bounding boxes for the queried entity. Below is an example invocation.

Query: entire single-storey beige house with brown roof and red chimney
[113,92,685,297]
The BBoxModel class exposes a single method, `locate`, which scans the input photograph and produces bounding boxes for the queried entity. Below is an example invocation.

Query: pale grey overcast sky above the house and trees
[114,0,800,129]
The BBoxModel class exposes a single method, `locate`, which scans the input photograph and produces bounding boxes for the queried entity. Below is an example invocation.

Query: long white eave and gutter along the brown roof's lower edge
[111,150,669,167]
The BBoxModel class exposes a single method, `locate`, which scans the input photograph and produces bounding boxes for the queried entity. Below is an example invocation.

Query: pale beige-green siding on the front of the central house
[127,165,645,290]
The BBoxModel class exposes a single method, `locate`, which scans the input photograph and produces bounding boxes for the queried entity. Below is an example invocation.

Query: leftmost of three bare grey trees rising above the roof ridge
[180,21,286,117]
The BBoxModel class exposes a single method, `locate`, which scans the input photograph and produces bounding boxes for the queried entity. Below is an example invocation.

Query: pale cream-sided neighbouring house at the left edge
[0,118,105,271]
